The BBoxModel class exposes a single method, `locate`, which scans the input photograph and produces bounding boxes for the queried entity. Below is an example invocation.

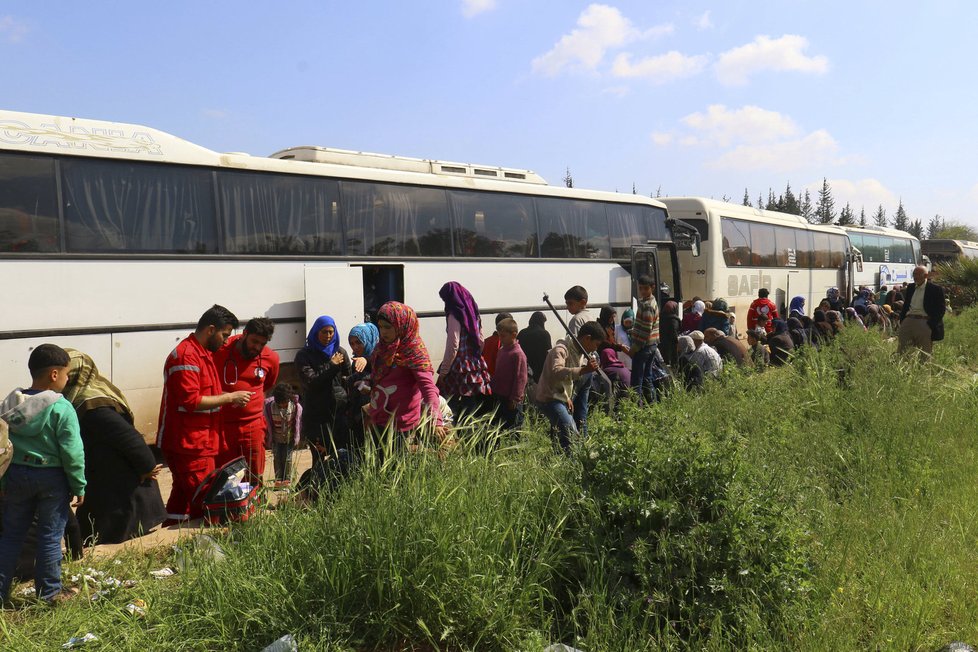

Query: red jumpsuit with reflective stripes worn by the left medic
[156,333,221,521]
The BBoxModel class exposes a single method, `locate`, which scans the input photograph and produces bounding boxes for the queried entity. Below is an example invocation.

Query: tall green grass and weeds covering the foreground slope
[0,310,978,651]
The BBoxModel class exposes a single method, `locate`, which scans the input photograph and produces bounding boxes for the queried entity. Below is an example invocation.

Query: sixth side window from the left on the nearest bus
[536,198,611,258]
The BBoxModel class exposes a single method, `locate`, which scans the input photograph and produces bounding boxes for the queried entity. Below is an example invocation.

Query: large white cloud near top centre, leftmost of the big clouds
[532,4,673,76]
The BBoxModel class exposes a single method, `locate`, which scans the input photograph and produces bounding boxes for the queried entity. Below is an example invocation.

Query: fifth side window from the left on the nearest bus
[448,190,537,258]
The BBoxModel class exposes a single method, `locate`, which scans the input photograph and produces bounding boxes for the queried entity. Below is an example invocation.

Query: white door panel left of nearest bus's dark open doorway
[305,265,363,336]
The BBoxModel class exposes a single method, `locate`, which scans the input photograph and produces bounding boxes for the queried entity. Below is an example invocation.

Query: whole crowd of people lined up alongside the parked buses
[0,267,945,602]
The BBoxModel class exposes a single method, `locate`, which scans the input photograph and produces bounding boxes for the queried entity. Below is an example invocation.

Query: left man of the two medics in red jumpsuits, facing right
[156,304,251,525]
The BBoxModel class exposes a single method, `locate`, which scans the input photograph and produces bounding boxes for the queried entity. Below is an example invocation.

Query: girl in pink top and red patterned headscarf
[367,301,447,436]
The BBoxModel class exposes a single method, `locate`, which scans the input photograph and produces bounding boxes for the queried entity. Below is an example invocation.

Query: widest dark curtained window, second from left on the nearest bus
[61,158,217,254]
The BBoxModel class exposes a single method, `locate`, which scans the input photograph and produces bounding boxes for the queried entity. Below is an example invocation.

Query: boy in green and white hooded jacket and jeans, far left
[0,344,85,604]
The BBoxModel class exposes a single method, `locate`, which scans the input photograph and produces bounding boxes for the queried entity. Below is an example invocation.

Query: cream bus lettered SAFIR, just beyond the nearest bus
[661,197,857,337]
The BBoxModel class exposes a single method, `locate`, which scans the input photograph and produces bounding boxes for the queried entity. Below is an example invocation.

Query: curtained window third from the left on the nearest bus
[217,172,343,255]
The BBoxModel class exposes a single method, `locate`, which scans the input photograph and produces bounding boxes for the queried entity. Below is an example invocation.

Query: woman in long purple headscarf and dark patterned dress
[438,281,492,415]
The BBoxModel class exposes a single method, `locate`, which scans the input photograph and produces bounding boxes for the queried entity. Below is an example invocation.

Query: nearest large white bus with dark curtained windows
[0,111,678,435]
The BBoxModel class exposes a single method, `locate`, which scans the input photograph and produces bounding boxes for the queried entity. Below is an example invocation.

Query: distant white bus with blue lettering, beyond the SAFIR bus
[842,226,924,290]
